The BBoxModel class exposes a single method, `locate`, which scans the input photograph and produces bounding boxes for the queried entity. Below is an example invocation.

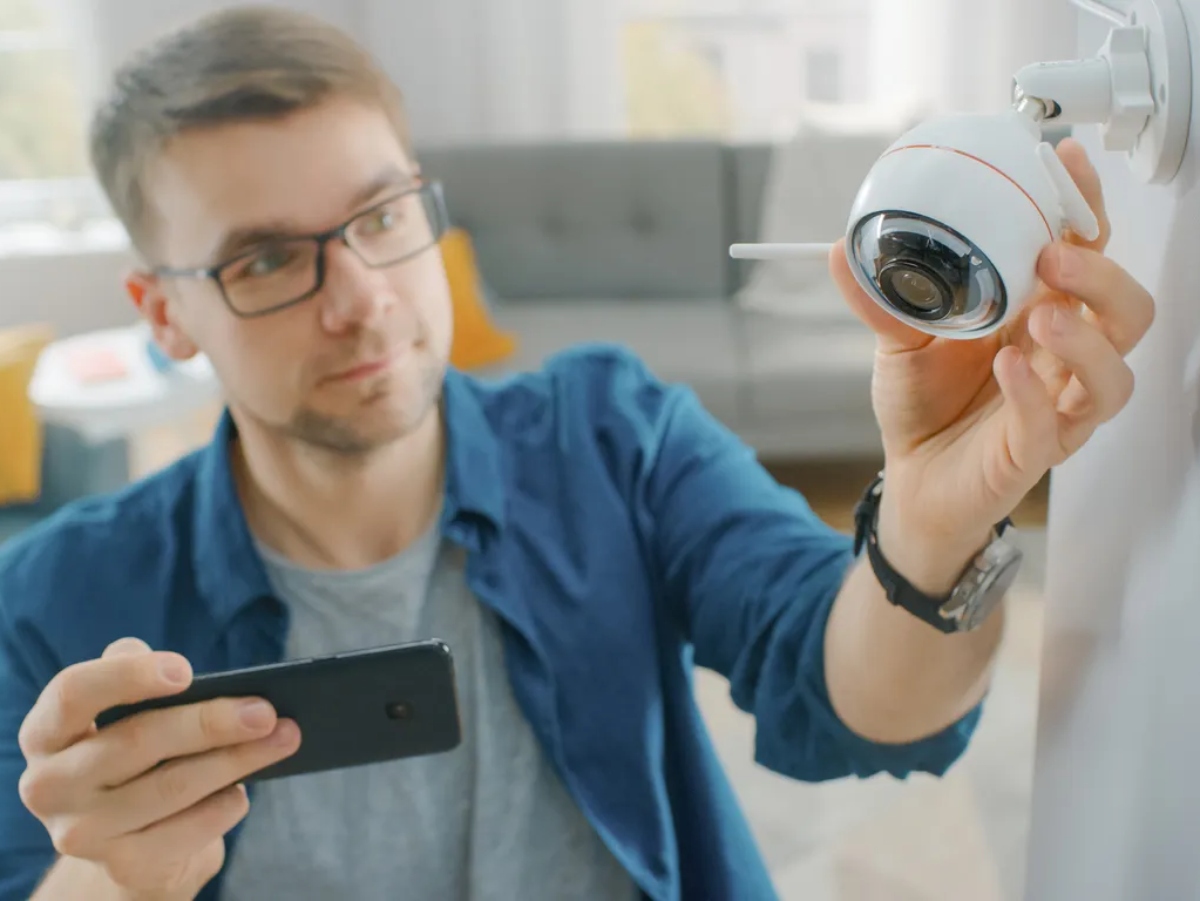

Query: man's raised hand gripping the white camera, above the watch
[830,139,1154,593]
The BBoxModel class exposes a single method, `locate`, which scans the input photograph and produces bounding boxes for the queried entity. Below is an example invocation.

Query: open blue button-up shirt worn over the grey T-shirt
[0,346,979,901]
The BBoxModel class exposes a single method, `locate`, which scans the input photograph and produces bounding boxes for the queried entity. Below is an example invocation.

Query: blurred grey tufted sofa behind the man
[419,140,880,459]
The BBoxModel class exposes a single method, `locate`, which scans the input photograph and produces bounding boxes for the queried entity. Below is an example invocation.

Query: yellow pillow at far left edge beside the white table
[0,324,54,504]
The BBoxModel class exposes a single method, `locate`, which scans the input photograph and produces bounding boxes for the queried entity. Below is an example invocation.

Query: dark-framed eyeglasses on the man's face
[154,181,450,318]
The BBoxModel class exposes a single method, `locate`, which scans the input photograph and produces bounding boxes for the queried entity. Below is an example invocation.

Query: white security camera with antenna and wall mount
[730,0,1192,340]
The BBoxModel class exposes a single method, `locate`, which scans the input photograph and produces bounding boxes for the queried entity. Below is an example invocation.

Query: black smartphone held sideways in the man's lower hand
[96,641,462,781]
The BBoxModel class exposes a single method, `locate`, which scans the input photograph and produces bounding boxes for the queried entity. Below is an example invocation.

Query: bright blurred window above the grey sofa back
[618,0,1022,142]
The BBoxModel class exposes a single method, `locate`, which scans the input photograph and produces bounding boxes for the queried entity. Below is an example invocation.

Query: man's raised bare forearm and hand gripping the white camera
[824,140,1154,743]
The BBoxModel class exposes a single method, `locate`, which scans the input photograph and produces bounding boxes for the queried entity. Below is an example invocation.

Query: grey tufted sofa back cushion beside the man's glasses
[419,140,730,302]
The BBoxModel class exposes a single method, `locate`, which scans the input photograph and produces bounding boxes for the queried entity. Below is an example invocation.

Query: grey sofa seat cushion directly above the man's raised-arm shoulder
[490,299,745,431]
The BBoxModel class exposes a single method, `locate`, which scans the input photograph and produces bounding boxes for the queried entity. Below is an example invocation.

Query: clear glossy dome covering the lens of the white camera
[851,211,1007,331]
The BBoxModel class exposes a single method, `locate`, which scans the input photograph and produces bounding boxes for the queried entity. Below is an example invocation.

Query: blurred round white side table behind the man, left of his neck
[29,325,221,444]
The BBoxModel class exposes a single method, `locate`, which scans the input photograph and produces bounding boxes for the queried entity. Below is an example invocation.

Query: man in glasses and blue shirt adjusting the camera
[0,7,1153,901]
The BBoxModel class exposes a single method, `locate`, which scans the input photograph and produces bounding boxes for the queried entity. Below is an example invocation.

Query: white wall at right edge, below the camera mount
[1027,0,1200,901]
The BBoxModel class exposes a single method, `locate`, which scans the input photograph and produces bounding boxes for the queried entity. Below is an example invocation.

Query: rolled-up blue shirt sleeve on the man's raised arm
[600,345,982,781]
